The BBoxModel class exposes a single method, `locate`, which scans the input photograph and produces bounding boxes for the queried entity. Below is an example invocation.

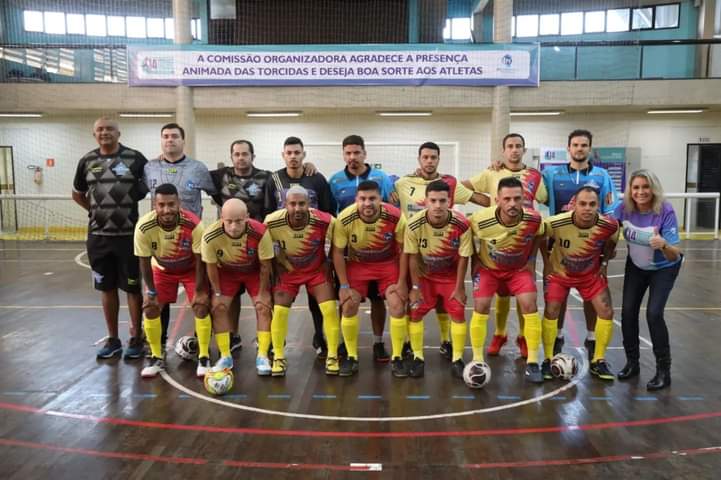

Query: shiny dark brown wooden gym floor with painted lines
[0,241,721,479]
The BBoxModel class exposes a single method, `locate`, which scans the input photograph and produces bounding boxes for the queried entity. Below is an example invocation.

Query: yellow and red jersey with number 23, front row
[403,209,473,280]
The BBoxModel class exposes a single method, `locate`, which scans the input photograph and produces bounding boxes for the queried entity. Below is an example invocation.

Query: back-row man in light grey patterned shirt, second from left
[144,123,215,349]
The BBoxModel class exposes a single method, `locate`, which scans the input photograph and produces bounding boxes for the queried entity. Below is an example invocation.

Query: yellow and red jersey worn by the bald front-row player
[201,218,274,273]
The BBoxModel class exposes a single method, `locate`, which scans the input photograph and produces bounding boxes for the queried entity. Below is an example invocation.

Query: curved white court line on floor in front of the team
[160,348,588,422]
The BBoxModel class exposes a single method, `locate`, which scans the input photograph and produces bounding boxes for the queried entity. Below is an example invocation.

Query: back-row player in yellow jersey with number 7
[395,142,488,360]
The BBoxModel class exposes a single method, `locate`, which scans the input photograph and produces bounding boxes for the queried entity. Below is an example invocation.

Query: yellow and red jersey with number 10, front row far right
[545,212,620,278]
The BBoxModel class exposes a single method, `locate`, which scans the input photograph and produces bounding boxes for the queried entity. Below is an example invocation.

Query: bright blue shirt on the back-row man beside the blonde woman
[542,164,618,215]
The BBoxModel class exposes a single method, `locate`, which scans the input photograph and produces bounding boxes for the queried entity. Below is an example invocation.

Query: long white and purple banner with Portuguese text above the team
[128,44,539,87]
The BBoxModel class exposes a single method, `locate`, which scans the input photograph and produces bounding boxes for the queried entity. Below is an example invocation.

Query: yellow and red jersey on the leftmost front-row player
[134,209,203,273]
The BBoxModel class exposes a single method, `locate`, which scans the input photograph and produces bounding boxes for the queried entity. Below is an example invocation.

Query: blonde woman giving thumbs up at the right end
[614,169,683,390]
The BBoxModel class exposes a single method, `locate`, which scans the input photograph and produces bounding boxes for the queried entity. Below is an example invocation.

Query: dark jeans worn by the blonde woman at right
[621,257,682,368]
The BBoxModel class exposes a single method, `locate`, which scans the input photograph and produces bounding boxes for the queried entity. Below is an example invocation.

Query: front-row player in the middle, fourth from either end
[333,180,407,376]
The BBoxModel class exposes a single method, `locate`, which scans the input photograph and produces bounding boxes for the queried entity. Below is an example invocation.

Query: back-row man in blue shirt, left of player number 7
[328,135,402,362]
